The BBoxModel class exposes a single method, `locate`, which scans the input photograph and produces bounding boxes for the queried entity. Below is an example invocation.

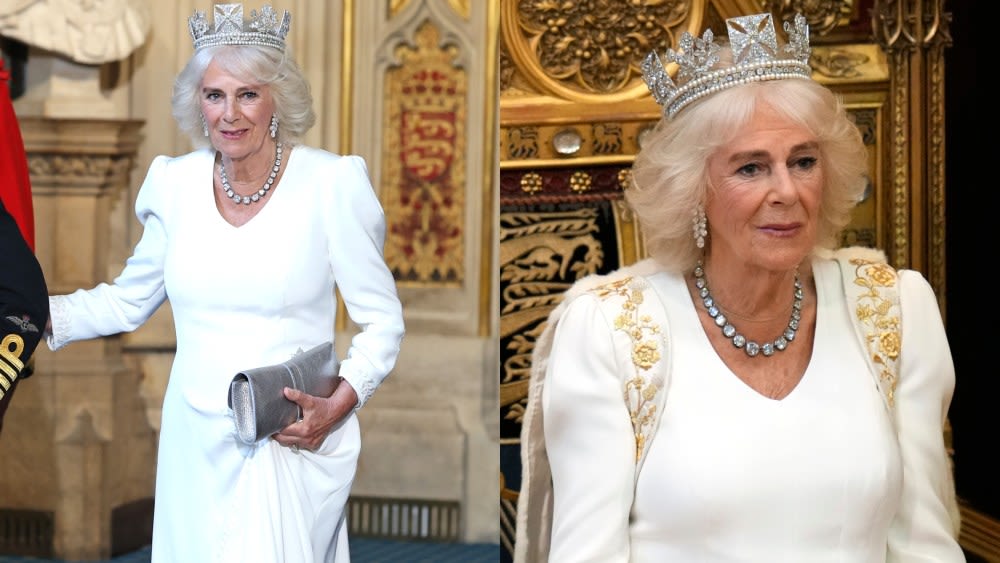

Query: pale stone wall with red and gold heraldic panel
[345,0,499,543]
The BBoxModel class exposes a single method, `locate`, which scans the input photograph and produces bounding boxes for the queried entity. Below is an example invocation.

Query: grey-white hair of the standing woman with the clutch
[170,45,316,147]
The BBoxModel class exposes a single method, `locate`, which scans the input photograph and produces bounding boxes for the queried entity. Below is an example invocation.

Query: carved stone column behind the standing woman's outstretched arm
[0,117,156,560]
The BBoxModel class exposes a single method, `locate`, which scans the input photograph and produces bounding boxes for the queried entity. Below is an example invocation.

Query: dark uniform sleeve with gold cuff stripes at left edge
[0,201,49,434]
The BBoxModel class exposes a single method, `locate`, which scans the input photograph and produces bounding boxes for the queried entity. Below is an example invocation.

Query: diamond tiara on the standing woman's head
[188,4,292,52]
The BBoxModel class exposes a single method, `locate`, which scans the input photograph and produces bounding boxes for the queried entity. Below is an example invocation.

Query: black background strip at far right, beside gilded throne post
[945,0,1000,519]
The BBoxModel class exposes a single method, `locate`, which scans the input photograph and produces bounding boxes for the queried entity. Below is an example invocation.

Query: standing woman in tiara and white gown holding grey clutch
[48,4,403,563]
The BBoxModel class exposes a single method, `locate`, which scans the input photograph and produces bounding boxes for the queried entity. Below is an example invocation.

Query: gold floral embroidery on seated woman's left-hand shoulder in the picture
[593,276,663,461]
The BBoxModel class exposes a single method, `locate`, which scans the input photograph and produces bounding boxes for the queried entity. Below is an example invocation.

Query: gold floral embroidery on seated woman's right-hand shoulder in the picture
[850,258,902,407]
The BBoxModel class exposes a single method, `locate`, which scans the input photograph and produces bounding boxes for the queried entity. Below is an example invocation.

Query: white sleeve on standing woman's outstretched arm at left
[46,156,171,350]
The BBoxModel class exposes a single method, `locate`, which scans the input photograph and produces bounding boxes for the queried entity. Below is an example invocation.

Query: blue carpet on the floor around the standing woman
[0,538,500,563]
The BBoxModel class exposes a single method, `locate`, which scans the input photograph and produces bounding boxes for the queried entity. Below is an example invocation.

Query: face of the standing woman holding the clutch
[201,61,274,164]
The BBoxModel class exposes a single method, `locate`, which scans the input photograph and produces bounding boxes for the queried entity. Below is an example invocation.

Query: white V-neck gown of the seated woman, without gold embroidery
[542,260,964,563]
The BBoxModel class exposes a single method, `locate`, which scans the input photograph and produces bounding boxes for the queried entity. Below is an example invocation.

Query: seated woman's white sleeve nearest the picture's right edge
[887,270,965,563]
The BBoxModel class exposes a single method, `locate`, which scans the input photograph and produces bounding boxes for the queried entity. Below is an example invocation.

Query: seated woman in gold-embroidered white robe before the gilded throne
[515,9,964,563]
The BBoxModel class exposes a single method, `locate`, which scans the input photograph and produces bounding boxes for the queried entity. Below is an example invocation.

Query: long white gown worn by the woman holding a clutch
[49,146,403,563]
